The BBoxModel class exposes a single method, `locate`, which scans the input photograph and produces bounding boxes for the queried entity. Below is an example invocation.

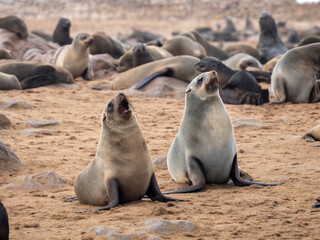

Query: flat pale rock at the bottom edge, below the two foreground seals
[144,218,196,235]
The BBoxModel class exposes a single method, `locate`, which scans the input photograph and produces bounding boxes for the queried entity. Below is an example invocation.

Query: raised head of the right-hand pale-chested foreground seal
[186,71,219,100]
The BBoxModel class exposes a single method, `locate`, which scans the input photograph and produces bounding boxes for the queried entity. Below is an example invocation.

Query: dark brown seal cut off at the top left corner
[0,16,28,38]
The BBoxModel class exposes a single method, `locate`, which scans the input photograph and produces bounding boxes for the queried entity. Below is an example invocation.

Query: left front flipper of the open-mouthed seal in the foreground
[76,178,120,213]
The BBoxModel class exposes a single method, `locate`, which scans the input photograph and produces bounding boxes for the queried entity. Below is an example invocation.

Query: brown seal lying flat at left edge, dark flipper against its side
[0,62,74,89]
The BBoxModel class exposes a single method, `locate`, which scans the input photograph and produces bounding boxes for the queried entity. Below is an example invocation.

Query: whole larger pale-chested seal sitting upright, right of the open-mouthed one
[167,71,276,193]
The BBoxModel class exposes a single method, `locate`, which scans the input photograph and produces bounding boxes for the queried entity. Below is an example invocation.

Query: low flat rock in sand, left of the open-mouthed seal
[5,171,66,190]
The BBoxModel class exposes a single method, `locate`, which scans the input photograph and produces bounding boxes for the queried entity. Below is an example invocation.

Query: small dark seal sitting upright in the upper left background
[52,18,72,46]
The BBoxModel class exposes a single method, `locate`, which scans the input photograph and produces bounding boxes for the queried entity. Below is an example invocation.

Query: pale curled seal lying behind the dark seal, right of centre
[222,53,262,70]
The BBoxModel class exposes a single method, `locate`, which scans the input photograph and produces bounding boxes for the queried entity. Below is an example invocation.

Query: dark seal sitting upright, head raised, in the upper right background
[258,12,287,64]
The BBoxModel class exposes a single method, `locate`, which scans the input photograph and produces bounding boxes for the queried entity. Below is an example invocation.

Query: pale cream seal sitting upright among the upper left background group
[53,33,94,80]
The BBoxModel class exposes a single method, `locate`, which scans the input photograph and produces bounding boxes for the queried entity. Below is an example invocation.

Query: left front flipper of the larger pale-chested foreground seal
[164,158,206,194]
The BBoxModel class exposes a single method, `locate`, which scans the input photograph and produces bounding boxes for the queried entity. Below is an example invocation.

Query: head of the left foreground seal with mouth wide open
[102,93,133,126]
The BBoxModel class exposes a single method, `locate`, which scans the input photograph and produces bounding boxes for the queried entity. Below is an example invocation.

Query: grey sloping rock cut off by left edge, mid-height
[0,140,24,171]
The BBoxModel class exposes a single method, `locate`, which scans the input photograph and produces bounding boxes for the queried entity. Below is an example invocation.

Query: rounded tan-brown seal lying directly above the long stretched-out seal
[162,36,207,59]
